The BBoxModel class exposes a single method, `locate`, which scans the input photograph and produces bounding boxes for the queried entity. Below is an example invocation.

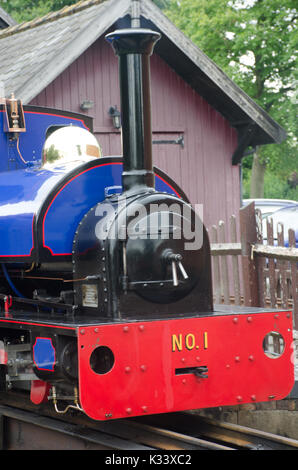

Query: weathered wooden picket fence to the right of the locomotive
[209,203,298,329]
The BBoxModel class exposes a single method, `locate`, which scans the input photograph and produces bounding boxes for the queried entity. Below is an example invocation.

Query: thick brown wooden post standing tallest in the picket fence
[239,202,260,307]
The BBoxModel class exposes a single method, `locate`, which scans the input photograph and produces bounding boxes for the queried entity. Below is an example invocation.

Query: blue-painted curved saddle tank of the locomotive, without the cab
[0,160,175,261]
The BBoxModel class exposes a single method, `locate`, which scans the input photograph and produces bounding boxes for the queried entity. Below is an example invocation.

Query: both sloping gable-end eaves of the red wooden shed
[3,0,286,156]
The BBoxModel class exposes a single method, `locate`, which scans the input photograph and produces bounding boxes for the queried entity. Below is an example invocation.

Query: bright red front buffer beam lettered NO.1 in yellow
[77,308,294,420]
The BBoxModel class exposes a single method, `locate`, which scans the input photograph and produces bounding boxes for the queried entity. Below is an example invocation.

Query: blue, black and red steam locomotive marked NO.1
[0,28,294,420]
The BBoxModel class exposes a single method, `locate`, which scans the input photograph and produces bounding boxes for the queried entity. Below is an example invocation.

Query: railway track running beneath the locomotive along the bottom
[0,392,298,452]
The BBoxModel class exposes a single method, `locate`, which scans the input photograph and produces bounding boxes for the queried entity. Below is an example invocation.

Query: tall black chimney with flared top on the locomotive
[106,28,160,191]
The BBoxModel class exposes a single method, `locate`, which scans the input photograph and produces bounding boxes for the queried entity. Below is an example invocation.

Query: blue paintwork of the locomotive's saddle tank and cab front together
[0,110,182,263]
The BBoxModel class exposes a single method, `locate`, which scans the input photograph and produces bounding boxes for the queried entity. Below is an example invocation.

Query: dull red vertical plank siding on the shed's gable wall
[31,38,240,230]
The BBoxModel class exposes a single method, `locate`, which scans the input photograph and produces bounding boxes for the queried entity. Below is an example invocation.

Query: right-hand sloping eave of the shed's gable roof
[141,0,287,146]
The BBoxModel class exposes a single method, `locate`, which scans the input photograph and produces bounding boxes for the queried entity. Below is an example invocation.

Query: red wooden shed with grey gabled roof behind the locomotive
[0,0,285,231]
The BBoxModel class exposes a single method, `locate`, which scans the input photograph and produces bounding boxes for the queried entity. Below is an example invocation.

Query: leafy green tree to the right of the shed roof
[166,0,298,197]
